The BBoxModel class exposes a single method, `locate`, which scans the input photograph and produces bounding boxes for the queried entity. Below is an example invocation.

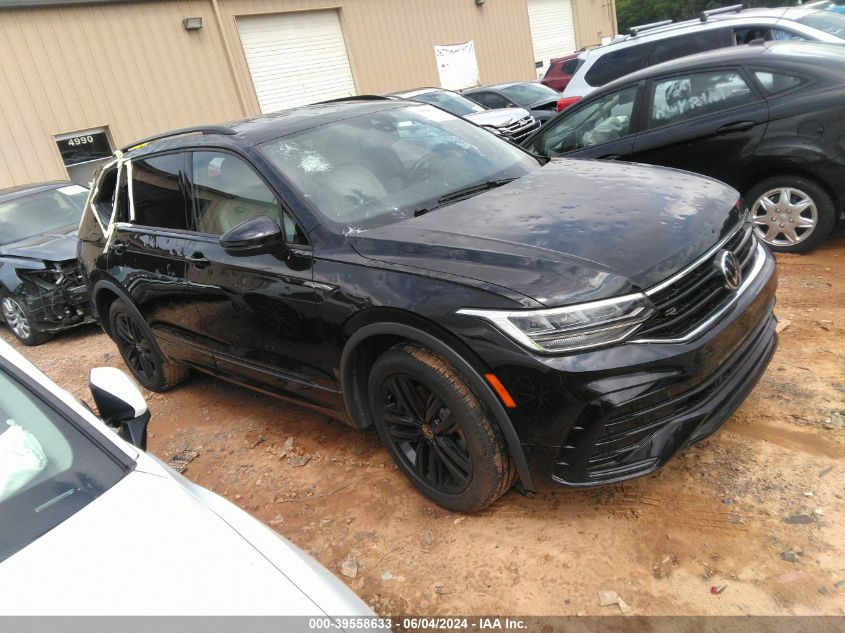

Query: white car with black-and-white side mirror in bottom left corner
[0,341,373,616]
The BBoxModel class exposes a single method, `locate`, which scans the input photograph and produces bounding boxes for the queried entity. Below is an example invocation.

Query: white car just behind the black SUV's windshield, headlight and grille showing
[386,88,540,143]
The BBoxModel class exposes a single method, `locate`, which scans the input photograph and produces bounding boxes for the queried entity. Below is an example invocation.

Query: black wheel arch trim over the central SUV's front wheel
[340,318,536,490]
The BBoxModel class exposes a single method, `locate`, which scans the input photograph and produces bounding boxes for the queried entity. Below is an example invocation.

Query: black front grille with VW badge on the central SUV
[637,226,756,338]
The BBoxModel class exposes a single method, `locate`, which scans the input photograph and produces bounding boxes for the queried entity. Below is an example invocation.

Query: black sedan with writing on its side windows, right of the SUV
[525,42,845,252]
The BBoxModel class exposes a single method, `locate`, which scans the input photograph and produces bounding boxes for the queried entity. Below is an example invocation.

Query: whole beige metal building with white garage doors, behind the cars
[0,0,616,188]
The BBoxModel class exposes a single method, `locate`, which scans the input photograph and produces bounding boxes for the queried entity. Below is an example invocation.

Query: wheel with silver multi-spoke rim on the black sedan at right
[746,174,836,253]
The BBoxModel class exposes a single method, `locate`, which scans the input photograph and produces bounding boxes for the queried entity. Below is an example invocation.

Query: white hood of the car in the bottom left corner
[0,464,372,615]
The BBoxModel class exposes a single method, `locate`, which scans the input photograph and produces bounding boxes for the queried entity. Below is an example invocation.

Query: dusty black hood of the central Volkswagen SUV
[352,159,740,306]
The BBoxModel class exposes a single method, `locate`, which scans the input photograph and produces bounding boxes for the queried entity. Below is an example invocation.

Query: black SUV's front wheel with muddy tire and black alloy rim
[369,344,516,512]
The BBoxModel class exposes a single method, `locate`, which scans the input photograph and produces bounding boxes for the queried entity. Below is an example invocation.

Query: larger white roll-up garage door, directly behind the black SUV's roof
[237,11,355,112]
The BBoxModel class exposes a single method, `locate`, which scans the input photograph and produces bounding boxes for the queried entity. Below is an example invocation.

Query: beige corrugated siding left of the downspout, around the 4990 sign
[0,0,246,187]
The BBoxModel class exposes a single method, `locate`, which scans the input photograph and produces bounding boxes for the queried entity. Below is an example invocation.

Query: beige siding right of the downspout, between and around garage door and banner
[220,0,534,110]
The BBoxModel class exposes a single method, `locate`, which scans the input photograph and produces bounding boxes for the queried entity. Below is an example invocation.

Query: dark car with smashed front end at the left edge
[0,181,93,345]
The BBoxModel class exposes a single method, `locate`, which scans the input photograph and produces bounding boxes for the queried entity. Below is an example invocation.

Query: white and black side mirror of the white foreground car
[88,367,150,451]
